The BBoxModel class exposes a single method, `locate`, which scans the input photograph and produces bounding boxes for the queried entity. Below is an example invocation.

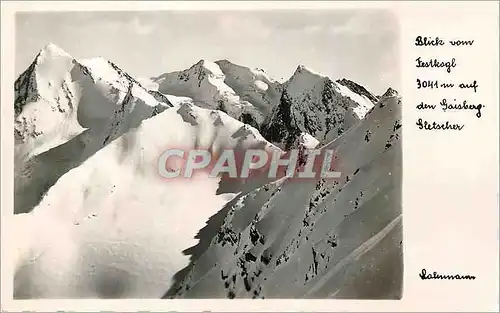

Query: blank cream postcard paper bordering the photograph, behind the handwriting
[1,1,499,312]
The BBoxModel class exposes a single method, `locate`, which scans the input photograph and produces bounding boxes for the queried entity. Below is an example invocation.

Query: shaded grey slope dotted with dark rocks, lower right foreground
[166,97,402,298]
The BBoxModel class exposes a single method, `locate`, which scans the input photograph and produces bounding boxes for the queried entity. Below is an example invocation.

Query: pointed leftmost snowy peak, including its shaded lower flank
[14,44,172,213]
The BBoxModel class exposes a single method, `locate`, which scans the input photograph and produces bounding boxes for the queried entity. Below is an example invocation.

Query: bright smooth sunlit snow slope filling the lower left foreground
[15,104,277,298]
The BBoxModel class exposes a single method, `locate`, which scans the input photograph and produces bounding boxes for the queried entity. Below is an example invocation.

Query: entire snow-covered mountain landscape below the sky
[13,44,402,298]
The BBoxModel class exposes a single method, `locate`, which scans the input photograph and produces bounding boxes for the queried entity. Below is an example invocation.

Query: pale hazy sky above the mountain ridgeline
[16,10,401,94]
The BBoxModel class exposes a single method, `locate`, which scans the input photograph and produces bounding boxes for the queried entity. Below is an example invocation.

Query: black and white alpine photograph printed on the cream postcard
[11,7,402,301]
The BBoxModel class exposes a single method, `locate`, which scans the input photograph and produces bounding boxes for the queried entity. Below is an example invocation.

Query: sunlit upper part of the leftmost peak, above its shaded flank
[15,44,170,158]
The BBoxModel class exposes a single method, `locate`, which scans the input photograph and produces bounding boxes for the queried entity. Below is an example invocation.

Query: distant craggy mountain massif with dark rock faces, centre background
[152,60,378,148]
